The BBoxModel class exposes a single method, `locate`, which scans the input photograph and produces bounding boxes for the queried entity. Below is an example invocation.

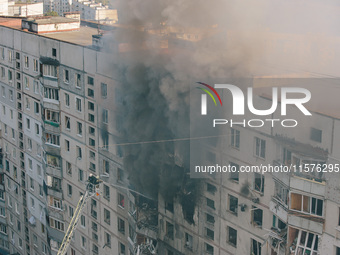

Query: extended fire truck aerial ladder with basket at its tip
[57,175,103,255]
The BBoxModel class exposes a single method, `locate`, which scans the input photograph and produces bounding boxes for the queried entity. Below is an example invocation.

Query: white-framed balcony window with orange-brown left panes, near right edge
[290,193,323,216]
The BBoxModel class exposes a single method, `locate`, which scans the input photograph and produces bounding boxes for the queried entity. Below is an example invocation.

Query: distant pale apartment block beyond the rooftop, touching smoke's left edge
[72,1,118,24]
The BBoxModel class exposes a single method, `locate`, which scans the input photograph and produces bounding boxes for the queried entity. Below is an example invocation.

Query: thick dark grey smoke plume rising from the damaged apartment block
[109,0,340,220]
